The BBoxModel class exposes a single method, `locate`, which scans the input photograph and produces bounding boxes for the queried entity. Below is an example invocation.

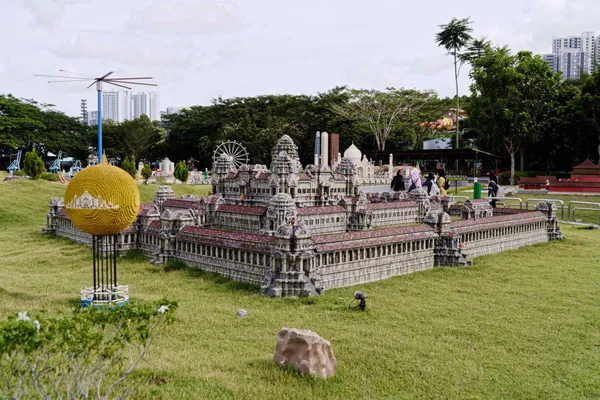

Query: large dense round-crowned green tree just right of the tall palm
[469,47,561,182]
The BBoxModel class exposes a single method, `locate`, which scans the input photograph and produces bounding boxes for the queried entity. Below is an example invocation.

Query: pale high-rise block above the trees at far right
[542,32,600,79]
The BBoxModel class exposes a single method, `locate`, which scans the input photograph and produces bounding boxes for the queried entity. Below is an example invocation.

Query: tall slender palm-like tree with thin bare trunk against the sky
[435,18,473,149]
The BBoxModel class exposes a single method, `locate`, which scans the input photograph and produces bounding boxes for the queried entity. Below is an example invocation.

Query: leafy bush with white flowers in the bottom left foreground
[0,300,177,399]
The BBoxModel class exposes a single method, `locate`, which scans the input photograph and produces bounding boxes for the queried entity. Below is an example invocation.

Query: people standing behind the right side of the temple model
[391,168,500,208]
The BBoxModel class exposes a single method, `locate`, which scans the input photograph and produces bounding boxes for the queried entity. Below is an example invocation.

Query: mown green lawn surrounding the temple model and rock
[0,177,600,399]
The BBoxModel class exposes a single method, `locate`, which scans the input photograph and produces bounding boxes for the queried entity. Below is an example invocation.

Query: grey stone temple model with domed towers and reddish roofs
[44,135,563,297]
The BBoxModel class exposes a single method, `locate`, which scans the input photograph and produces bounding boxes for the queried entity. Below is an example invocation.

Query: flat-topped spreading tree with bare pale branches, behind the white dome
[333,88,436,151]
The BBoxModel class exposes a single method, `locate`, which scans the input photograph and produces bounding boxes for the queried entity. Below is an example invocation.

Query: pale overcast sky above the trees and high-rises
[0,0,600,116]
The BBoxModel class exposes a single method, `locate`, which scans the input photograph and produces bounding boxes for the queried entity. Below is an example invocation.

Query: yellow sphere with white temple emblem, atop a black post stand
[65,157,140,235]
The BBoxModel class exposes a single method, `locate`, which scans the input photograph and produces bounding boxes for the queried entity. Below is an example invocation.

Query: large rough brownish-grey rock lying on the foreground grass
[273,328,337,378]
